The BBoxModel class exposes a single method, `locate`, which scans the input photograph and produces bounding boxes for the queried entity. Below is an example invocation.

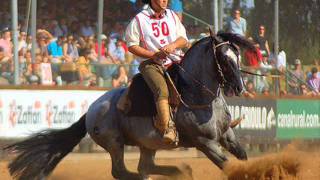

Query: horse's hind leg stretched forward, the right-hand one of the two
[138,147,192,179]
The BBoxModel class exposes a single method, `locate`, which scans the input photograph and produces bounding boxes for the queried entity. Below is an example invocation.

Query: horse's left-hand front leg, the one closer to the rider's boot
[196,137,227,169]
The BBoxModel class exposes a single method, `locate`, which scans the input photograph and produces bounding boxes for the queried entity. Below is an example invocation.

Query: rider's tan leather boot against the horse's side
[154,100,177,144]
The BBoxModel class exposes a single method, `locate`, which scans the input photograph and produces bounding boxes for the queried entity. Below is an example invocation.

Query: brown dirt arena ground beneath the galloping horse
[0,148,320,180]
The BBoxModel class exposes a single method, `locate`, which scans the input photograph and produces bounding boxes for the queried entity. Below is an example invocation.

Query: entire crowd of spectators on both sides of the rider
[0,0,320,98]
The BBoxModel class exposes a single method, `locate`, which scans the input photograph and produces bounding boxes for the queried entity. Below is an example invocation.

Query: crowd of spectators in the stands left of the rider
[0,0,140,87]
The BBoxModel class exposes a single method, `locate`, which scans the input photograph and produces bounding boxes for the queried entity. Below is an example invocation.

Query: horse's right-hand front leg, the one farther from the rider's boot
[220,128,248,160]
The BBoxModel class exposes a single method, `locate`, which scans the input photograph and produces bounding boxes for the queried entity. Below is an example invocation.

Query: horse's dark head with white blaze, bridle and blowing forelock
[212,33,253,96]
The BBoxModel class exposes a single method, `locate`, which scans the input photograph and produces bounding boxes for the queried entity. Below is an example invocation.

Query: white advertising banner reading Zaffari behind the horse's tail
[0,90,105,138]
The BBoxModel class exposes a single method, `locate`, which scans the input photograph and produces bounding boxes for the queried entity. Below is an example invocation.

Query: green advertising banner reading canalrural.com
[277,100,320,139]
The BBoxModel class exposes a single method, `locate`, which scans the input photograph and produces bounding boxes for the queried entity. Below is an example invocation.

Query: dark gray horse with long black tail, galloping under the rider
[6,33,253,180]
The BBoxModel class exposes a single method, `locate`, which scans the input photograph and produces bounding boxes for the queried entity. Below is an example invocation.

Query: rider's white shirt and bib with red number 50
[125,6,188,64]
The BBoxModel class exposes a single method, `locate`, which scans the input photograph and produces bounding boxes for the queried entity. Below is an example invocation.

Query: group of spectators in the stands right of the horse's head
[226,9,320,98]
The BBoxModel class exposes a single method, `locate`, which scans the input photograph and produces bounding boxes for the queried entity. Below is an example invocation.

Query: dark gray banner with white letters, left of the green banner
[226,97,276,139]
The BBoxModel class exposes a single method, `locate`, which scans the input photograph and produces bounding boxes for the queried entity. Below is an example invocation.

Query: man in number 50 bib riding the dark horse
[126,0,188,143]
